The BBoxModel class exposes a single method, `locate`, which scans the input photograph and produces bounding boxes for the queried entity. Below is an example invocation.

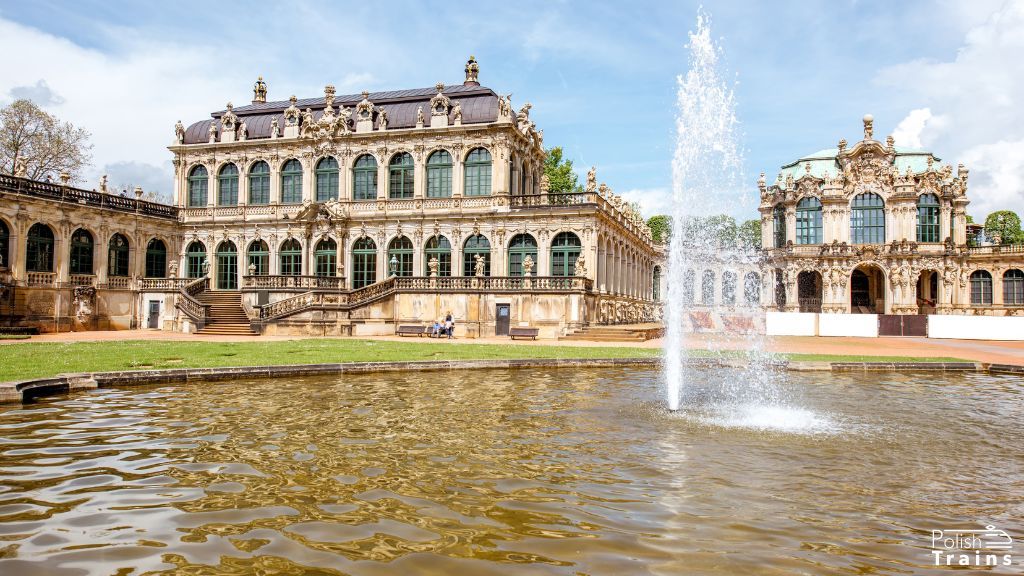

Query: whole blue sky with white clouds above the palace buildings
[0,0,1024,219]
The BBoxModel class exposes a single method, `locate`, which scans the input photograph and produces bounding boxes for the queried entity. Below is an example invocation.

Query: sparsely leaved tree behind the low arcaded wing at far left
[0,99,92,181]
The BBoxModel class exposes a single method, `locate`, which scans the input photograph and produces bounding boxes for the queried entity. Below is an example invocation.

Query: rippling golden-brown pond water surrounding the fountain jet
[0,369,1024,574]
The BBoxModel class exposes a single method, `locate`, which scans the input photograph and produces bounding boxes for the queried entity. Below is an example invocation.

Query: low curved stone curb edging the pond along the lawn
[0,357,1024,404]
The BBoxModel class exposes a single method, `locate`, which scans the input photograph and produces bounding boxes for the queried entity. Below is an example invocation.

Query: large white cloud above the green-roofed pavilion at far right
[877,0,1024,219]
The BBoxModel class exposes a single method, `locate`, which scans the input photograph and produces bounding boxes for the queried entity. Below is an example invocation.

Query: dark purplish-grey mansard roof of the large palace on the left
[184,83,498,145]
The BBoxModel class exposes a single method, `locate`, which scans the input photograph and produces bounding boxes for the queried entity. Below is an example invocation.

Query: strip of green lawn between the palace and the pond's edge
[0,338,963,381]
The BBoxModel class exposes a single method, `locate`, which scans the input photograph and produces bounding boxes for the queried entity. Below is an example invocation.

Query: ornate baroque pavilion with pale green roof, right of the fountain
[758,115,1024,316]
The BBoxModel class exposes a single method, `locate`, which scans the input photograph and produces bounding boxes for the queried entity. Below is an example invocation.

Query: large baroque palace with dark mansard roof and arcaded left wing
[0,57,664,337]
